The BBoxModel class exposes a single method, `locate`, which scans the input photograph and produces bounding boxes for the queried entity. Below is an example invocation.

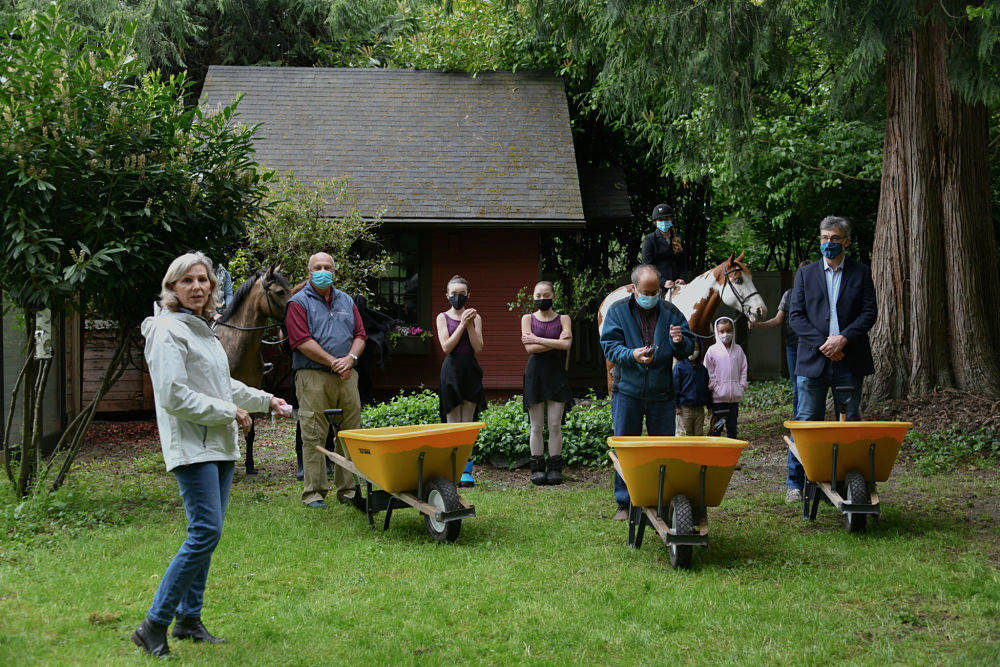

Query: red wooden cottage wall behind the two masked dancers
[373,229,539,392]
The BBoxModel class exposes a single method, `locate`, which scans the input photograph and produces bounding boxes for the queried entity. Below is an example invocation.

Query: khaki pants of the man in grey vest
[295,368,361,503]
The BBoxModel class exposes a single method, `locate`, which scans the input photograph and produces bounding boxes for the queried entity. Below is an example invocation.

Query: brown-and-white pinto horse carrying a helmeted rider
[597,253,767,394]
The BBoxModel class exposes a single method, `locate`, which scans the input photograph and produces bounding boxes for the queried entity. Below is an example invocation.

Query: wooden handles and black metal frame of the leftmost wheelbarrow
[316,409,476,542]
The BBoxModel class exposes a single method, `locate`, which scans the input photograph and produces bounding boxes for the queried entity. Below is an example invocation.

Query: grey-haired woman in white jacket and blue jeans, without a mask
[132,252,290,657]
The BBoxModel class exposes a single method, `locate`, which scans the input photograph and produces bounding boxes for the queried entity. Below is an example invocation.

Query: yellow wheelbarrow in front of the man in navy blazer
[785,421,913,533]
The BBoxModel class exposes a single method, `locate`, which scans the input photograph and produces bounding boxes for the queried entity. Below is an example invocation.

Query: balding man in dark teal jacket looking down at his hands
[601,264,694,521]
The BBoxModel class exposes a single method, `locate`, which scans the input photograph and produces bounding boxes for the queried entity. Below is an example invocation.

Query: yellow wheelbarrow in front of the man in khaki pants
[316,410,484,542]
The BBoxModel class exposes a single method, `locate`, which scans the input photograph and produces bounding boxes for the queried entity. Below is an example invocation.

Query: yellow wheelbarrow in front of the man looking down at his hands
[608,436,748,567]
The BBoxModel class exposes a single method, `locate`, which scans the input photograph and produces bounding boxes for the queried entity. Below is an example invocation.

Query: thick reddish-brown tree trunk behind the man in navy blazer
[870,20,1000,400]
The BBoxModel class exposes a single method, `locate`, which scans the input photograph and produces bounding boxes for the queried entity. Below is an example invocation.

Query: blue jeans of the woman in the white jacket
[147,461,234,625]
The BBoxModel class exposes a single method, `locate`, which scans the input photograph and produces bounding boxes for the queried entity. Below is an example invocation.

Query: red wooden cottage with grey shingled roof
[201,67,628,393]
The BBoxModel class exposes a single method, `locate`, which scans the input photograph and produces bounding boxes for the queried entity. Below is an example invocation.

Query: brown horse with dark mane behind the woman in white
[215,266,292,475]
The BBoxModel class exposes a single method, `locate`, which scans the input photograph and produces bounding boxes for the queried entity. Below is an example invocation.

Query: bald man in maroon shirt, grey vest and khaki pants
[285,252,367,507]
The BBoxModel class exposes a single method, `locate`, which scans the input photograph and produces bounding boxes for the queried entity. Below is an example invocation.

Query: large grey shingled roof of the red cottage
[201,67,584,227]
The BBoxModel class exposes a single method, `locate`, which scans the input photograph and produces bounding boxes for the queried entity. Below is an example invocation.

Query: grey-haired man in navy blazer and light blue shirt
[785,216,877,502]
